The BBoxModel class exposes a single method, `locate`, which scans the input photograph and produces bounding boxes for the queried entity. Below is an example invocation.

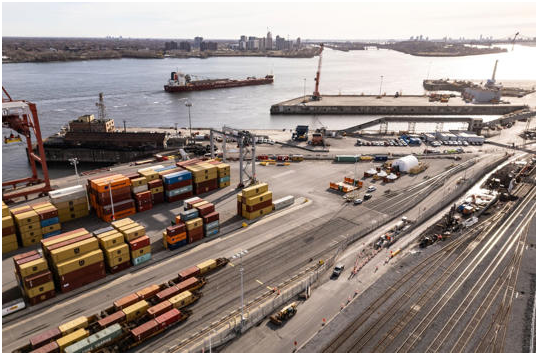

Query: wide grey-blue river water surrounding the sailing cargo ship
[2,46,536,181]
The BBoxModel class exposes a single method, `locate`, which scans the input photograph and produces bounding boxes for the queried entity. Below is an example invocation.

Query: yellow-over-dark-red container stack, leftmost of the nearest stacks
[13,250,56,306]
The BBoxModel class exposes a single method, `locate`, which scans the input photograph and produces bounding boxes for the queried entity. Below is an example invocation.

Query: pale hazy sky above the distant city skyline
[2,2,536,39]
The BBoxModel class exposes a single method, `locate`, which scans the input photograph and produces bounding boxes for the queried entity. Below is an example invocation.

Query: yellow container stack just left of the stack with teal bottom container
[93,227,131,274]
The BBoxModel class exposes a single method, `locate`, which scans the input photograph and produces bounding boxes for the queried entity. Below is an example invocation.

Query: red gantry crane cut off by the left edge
[2,86,51,203]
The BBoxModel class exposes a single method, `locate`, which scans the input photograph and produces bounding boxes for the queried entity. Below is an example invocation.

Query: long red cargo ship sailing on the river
[164,71,274,92]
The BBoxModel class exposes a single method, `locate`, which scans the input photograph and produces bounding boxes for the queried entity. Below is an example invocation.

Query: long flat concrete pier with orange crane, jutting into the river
[271,95,528,115]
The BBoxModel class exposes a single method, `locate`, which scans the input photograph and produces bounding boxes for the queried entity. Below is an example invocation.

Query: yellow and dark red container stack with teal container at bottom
[112,218,151,266]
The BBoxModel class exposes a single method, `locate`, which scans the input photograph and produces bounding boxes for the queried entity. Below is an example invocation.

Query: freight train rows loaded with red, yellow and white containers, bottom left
[14,258,229,353]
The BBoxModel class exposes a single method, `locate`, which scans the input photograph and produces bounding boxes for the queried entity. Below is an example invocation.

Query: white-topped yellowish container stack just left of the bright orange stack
[49,185,89,223]
